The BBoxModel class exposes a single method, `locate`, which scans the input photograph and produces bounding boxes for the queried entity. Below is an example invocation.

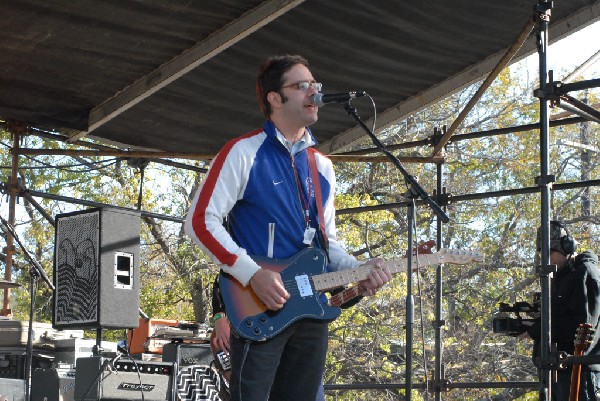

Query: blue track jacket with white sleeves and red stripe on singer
[185,121,360,286]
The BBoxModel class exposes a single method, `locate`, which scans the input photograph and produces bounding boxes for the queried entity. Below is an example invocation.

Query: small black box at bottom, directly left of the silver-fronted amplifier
[31,367,75,401]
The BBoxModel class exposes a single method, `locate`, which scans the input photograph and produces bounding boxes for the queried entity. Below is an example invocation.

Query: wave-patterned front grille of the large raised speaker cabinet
[55,211,100,324]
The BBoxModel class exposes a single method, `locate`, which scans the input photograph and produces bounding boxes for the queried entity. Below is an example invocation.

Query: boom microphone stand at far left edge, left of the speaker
[0,216,54,401]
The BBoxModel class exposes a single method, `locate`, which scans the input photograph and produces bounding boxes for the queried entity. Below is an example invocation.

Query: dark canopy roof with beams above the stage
[0,0,600,154]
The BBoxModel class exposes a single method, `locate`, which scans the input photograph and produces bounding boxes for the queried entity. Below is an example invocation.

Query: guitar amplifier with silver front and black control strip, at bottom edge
[75,356,177,401]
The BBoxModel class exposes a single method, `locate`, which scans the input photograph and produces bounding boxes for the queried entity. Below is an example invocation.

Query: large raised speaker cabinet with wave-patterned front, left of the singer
[53,208,141,329]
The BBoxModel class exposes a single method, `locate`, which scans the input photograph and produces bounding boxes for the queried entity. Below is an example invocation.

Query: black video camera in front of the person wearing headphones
[492,292,541,337]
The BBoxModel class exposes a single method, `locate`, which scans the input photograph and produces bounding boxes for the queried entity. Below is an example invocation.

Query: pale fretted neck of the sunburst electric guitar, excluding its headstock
[312,254,443,291]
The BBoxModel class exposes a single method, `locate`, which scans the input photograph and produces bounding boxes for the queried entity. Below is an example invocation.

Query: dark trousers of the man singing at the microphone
[230,319,328,401]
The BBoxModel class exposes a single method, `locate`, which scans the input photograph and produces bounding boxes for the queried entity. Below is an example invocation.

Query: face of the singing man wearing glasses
[277,64,318,128]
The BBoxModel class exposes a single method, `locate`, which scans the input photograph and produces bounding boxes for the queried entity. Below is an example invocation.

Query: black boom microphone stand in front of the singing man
[343,101,450,401]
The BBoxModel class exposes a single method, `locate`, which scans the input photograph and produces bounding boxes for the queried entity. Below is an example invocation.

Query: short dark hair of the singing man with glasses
[256,54,308,118]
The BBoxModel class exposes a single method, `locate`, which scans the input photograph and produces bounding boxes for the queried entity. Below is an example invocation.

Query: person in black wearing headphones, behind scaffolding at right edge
[527,220,600,401]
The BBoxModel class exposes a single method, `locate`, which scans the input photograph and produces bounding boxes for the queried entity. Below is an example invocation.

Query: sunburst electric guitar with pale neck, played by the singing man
[219,248,483,341]
